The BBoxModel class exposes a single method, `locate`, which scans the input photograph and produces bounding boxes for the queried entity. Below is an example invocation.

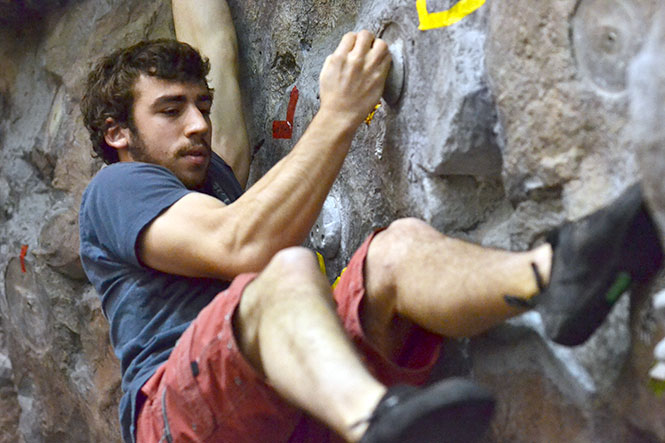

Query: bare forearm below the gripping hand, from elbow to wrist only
[227,111,357,267]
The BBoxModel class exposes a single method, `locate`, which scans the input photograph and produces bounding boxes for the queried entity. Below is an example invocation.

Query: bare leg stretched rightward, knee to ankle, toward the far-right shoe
[363,219,552,360]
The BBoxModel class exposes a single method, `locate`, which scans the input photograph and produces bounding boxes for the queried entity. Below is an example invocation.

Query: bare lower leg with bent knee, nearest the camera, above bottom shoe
[234,248,386,441]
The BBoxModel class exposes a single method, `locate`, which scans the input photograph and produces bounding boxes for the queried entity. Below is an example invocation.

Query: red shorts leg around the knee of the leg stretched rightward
[334,230,443,385]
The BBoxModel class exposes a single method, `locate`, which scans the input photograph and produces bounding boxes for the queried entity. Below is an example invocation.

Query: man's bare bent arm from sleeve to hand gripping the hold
[139,31,390,279]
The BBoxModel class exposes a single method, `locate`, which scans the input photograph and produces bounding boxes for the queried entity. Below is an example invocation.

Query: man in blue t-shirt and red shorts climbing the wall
[80,0,651,442]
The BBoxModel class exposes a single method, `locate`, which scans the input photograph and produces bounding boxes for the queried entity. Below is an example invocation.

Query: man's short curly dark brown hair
[81,39,210,164]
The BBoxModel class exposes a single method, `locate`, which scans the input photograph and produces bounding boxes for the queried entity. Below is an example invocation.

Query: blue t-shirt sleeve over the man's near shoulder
[80,162,192,266]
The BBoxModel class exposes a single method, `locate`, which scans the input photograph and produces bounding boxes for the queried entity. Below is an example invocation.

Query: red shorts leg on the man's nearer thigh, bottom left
[137,275,302,443]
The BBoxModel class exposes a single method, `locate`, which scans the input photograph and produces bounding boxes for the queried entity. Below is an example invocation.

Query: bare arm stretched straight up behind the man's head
[172,0,250,188]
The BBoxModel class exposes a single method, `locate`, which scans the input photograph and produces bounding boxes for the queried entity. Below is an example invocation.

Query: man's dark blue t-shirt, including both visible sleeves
[79,154,242,442]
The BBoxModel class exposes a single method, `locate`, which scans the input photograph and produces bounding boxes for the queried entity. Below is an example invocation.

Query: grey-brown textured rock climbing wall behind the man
[0,0,665,442]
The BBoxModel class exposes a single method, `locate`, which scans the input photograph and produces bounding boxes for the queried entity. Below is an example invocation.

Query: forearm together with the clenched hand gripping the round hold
[233,31,390,256]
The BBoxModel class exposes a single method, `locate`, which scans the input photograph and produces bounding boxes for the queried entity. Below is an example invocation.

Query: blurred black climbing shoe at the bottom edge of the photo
[361,378,494,443]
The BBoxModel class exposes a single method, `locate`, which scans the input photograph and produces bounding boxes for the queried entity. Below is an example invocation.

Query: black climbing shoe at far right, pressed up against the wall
[533,185,663,346]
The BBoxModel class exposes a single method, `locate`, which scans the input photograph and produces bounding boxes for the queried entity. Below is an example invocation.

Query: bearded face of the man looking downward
[128,75,212,189]
